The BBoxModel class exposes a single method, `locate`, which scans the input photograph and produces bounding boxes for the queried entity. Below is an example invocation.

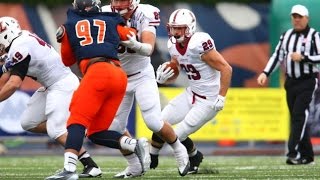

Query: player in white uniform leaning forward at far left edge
[0,17,101,176]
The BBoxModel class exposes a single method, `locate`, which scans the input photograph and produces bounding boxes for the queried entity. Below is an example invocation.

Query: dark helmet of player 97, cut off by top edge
[72,0,101,12]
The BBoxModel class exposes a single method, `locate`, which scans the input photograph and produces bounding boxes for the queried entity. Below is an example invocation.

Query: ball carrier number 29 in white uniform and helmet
[154,9,232,173]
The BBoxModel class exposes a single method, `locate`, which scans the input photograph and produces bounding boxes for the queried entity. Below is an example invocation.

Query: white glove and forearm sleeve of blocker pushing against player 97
[120,31,152,56]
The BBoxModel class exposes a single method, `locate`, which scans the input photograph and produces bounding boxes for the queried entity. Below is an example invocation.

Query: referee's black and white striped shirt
[263,26,320,78]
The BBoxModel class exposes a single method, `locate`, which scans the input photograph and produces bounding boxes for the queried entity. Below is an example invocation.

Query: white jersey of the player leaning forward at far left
[8,30,71,87]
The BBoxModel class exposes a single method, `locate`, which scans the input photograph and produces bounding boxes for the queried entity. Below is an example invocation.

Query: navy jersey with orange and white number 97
[64,9,124,61]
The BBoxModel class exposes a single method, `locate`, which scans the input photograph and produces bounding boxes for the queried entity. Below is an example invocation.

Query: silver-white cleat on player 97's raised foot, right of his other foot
[134,137,151,174]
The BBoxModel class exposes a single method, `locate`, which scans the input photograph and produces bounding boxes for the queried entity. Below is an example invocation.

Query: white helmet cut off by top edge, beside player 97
[111,0,140,16]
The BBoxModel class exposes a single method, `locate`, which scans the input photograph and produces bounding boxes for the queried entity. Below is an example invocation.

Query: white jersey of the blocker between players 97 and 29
[102,4,160,75]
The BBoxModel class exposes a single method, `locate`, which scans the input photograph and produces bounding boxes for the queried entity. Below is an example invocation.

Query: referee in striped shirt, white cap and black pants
[257,4,320,165]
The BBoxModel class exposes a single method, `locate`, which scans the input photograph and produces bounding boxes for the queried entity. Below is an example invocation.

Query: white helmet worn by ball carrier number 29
[167,9,196,43]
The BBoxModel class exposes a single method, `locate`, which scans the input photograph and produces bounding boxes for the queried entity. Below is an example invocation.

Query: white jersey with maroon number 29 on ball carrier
[168,32,220,98]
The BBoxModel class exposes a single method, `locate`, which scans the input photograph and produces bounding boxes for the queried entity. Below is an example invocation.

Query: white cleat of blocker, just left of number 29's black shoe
[174,146,190,176]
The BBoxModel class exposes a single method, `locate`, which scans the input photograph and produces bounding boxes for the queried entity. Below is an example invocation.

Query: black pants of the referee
[284,77,317,160]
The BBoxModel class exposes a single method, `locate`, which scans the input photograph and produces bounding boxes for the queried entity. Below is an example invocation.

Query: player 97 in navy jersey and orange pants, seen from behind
[47,0,150,179]
